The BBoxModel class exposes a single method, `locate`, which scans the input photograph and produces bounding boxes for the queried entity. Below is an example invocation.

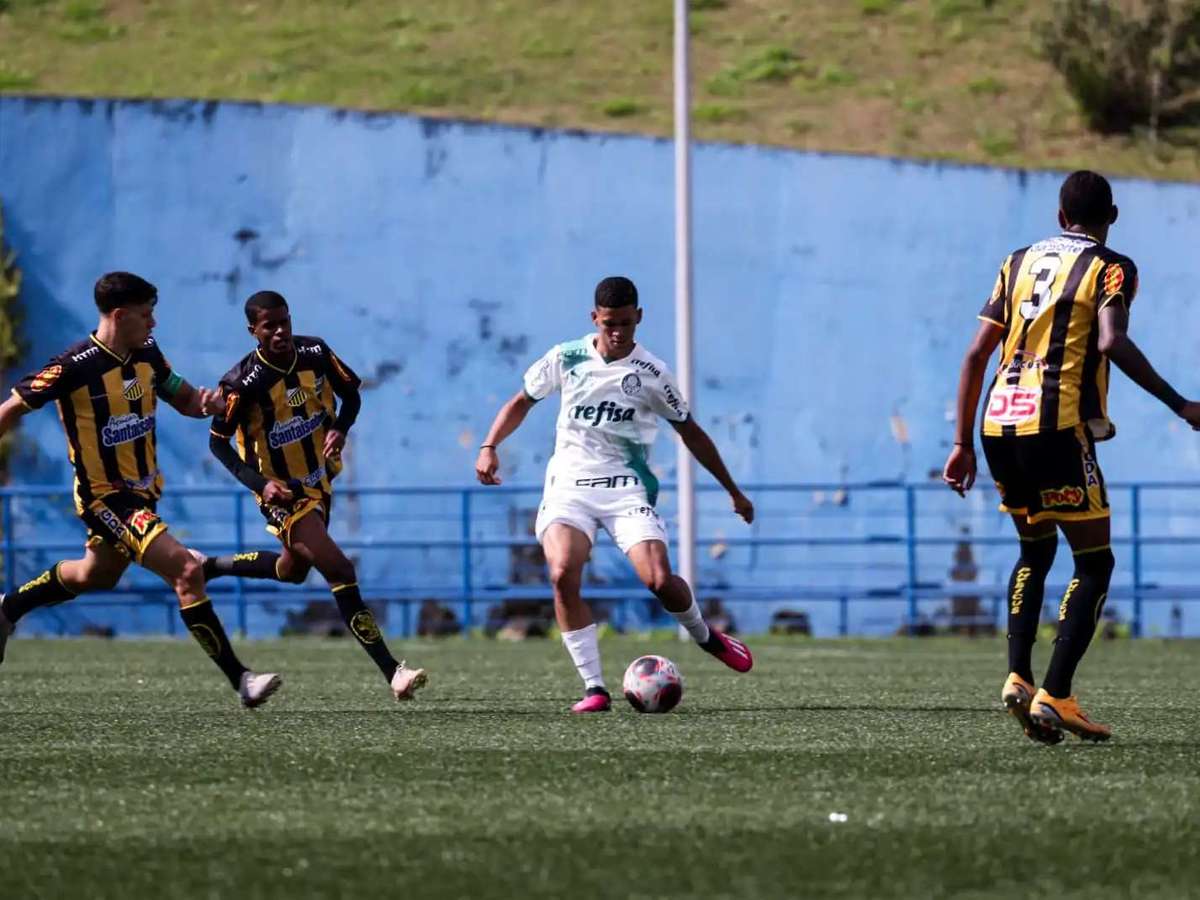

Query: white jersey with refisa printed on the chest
[524,334,689,506]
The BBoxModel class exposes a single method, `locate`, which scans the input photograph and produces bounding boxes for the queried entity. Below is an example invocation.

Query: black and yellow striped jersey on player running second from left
[212,336,361,499]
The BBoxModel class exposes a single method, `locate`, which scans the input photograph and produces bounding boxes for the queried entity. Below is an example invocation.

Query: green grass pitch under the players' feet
[0,638,1200,900]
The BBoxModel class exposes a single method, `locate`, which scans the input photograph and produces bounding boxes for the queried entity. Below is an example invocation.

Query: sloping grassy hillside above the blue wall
[0,0,1200,180]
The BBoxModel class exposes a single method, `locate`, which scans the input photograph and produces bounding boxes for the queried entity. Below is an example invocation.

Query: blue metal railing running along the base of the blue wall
[7,482,1200,636]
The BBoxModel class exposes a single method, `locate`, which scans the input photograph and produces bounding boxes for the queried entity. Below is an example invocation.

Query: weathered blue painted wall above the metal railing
[0,97,1200,633]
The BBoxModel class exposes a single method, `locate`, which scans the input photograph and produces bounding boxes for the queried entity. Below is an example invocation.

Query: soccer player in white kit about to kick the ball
[475,276,754,713]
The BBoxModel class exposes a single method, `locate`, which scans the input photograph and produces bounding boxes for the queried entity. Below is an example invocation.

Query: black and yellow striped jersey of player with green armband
[13,334,172,510]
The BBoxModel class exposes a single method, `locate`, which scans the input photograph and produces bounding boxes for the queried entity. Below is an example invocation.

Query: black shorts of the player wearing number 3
[983,425,1109,524]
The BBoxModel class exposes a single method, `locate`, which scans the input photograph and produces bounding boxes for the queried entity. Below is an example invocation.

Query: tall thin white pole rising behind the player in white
[674,0,696,638]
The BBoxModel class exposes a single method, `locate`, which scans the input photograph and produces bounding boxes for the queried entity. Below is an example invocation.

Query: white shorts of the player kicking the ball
[534,487,667,553]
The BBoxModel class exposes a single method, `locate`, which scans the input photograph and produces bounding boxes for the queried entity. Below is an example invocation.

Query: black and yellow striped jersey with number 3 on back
[979,233,1138,440]
